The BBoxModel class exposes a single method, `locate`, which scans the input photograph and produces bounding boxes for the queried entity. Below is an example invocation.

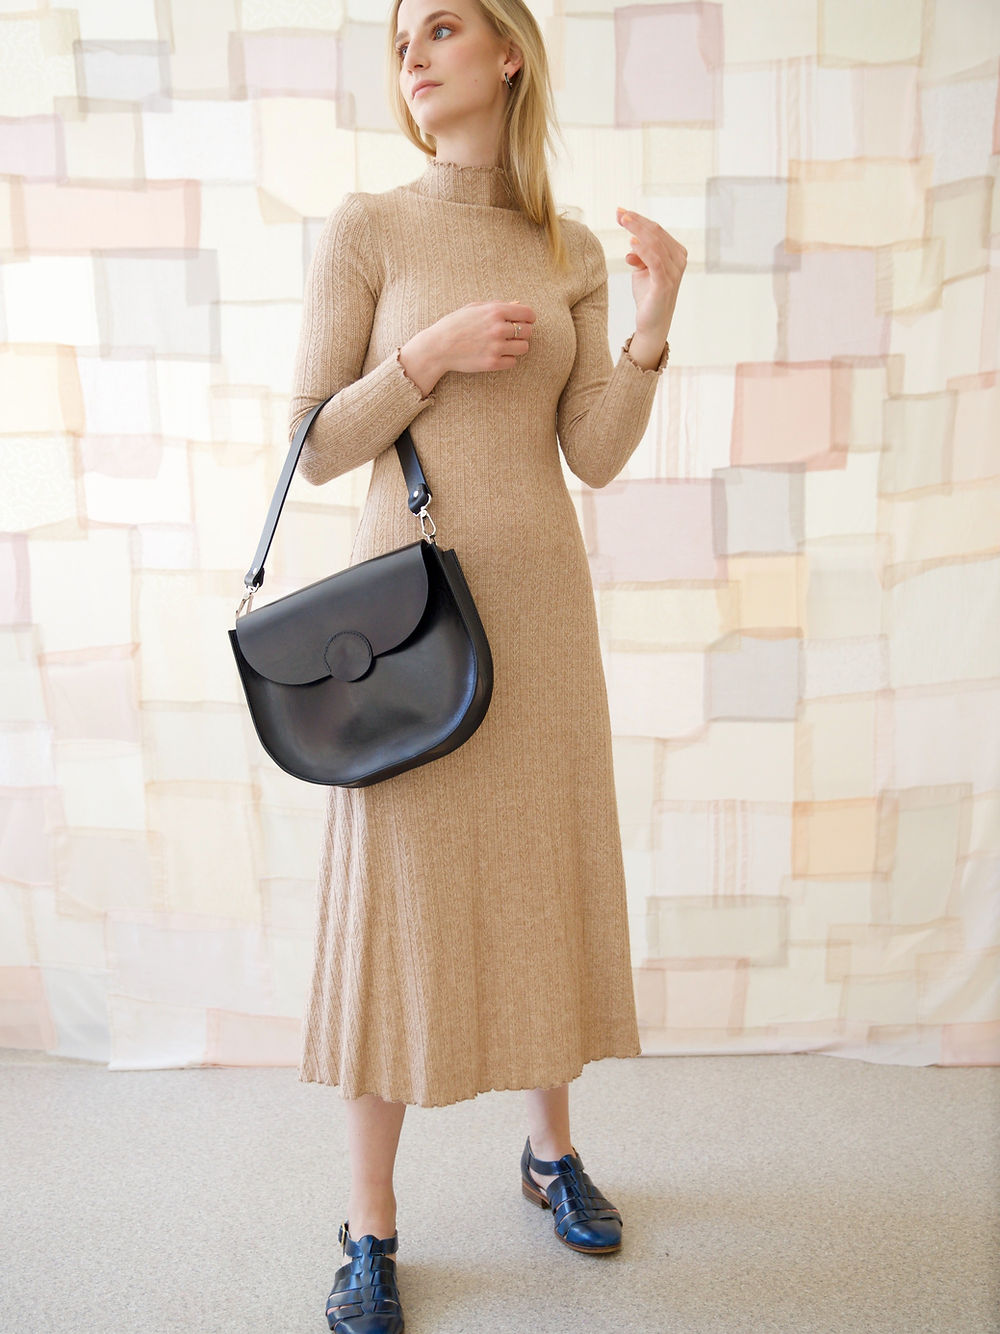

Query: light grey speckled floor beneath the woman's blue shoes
[0,1050,1000,1334]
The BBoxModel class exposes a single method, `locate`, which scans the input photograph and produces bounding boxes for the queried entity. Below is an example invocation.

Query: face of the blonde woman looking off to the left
[396,0,508,139]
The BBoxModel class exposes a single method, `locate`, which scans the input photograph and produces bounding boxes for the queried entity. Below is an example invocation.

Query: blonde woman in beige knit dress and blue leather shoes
[289,0,687,1334]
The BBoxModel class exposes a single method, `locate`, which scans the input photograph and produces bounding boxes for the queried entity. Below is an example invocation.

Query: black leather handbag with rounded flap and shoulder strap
[228,399,493,787]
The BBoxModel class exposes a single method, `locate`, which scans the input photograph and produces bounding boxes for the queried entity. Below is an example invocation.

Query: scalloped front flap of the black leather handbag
[236,538,429,686]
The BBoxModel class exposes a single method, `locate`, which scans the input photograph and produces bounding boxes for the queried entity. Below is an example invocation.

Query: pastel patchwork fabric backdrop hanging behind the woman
[0,0,1000,1070]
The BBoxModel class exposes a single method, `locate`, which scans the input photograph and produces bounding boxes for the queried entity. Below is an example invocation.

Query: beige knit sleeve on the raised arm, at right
[556,228,668,487]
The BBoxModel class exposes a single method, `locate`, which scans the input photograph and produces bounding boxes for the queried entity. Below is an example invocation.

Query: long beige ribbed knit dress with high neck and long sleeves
[289,159,667,1107]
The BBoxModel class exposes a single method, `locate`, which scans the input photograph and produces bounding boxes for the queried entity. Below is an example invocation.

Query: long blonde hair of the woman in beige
[387,0,569,269]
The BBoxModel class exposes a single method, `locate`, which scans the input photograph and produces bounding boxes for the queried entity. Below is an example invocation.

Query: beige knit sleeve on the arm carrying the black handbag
[288,193,435,486]
